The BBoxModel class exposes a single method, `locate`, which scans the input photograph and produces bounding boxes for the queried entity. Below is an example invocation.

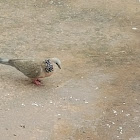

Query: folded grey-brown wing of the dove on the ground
[9,59,41,78]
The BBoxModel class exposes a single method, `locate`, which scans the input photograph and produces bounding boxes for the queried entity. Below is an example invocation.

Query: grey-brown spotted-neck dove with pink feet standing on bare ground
[0,58,61,85]
